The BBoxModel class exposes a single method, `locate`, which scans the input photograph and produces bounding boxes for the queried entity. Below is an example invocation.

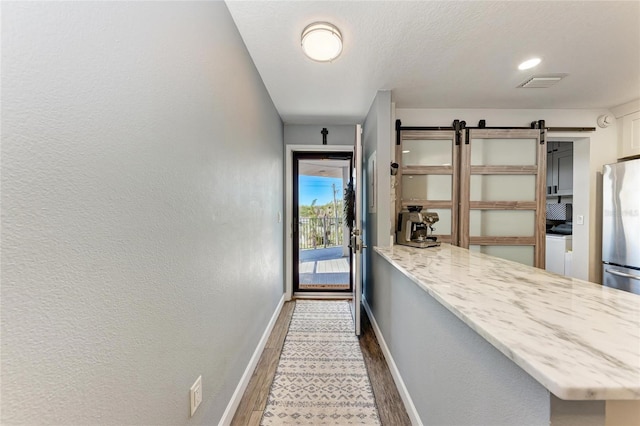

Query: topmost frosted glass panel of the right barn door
[471,139,538,166]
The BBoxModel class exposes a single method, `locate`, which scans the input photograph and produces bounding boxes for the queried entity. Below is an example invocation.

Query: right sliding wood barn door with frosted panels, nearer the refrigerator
[460,129,547,268]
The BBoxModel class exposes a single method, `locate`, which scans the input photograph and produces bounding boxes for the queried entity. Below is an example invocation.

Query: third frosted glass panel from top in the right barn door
[469,210,536,237]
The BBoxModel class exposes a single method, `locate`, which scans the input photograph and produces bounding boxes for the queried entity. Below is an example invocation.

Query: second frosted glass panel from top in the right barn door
[470,175,536,201]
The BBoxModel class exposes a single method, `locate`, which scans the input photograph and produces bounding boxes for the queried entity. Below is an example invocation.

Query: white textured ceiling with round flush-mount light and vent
[227,0,640,124]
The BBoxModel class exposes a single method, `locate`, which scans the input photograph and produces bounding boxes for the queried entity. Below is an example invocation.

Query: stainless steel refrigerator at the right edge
[602,159,640,295]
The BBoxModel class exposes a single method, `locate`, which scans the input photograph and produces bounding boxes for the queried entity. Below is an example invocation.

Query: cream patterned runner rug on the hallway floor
[260,300,380,426]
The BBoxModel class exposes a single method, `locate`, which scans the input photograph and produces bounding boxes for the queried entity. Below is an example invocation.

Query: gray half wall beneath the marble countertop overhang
[367,253,552,426]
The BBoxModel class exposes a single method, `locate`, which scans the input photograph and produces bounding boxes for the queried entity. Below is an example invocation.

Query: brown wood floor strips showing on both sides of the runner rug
[231,301,411,426]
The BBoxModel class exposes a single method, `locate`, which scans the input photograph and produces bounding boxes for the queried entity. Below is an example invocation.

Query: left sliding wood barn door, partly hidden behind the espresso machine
[395,130,459,245]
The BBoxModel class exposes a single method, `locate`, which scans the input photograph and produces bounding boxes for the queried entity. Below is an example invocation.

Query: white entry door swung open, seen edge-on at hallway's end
[351,124,365,336]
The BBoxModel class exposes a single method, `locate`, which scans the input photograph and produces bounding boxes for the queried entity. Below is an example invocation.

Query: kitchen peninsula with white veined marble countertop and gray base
[366,244,640,426]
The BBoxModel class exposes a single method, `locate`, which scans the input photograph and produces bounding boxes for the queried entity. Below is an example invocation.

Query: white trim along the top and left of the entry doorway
[284,145,353,301]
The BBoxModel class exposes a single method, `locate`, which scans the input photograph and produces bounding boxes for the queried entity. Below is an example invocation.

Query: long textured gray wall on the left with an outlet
[1,2,283,425]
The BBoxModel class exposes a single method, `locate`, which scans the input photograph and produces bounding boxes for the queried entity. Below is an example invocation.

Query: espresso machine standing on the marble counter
[396,206,440,248]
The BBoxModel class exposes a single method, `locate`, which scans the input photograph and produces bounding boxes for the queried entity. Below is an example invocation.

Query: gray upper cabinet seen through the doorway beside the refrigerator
[547,142,573,197]
